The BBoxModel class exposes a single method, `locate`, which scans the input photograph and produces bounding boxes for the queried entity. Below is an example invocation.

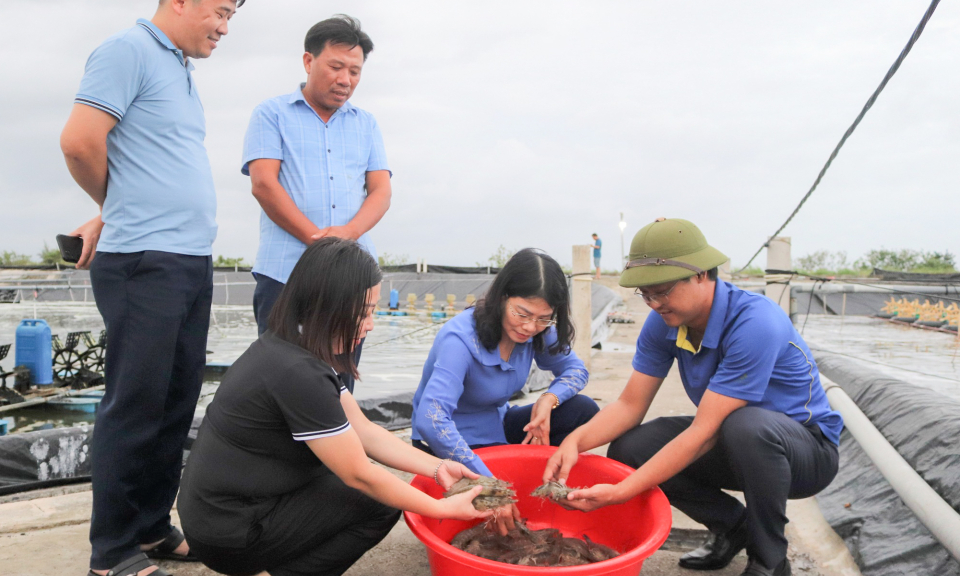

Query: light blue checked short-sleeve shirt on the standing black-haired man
[241,85,390,283]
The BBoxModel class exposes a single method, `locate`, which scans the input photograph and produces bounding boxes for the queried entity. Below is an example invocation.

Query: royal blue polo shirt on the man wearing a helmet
[633,280,843,444]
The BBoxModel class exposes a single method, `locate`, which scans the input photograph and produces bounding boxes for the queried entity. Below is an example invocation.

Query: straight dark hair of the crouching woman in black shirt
[268,237,382,377]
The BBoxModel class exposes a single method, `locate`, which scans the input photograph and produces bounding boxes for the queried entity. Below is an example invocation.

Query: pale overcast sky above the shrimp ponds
[0,0,960,268]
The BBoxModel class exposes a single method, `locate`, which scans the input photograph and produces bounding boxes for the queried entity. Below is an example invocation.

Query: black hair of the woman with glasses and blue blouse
[473,248,574,354]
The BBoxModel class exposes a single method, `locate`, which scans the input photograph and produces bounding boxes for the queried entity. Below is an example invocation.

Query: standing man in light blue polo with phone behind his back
[61,0,243,576]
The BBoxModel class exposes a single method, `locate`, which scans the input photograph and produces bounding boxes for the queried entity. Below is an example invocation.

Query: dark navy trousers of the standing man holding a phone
[90,251,213,570]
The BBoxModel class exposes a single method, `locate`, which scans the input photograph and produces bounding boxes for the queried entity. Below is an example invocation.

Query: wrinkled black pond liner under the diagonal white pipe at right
[817,352,960,576]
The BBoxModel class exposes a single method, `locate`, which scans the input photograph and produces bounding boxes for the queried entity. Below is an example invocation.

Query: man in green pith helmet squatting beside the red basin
[544,218,843,576]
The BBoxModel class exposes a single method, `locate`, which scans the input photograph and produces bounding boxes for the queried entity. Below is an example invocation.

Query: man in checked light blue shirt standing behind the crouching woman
[241,15,392,391]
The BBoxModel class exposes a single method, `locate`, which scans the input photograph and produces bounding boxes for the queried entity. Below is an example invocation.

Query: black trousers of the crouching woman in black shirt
[186,474,400,576]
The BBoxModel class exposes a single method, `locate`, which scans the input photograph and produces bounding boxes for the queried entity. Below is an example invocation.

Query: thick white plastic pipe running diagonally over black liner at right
[820,374,960,561]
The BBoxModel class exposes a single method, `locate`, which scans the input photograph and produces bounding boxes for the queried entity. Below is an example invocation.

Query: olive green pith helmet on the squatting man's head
[620,218,727,288]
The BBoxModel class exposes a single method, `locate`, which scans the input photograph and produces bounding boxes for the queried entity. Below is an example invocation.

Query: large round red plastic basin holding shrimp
[404,445,673,576]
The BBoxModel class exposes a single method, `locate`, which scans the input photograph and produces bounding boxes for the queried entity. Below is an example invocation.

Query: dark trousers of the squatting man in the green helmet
[607,406,838,568]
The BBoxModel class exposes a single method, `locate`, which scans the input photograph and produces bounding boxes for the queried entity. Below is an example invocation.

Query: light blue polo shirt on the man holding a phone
[74,19,217,256]
